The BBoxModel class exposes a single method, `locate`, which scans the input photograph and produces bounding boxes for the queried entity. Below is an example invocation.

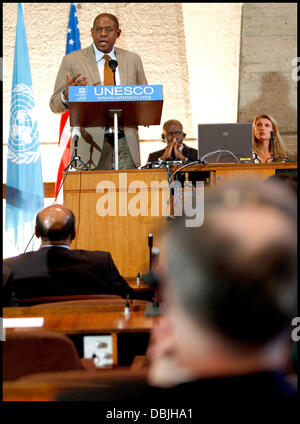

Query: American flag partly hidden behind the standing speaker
[55,3,81,197]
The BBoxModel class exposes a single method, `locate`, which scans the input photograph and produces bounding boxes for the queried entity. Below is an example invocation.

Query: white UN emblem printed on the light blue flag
[8,84,40,164]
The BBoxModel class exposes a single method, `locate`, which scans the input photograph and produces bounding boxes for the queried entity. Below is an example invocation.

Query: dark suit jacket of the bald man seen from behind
[3,246,134,301]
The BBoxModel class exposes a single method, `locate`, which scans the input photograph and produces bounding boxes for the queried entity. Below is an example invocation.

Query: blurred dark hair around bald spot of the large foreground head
[166,181,297,348]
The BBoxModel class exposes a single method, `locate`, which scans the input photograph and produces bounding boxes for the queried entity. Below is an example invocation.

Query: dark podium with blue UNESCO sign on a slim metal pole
[69,85,163,170]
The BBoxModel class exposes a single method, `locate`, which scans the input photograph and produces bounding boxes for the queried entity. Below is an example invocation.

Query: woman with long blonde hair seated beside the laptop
[253,114,287,163]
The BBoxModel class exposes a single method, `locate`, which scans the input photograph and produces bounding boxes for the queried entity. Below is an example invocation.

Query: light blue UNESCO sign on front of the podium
[69,85,163,102]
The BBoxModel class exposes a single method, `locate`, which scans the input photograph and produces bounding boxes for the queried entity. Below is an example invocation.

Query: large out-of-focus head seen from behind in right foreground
[160,180,297,356]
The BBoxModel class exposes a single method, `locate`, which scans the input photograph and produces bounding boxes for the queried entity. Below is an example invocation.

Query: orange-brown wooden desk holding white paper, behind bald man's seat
[3,301,160,366]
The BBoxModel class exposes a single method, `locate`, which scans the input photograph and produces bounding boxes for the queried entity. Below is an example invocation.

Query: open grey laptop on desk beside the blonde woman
[198,122,252,163]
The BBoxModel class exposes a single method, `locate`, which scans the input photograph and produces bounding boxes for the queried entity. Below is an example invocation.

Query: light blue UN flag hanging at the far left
[5,3,44,253]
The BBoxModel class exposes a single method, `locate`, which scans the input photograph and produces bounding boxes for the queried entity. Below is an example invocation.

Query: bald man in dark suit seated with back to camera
[3,205,134,306]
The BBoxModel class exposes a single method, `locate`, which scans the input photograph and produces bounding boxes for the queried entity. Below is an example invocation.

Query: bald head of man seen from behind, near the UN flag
[35,205,75,244]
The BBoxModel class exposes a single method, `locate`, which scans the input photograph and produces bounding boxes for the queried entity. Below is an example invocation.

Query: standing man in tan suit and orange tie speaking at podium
[50,13,147,169]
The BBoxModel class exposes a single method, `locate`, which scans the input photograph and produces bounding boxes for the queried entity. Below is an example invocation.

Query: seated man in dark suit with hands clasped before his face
[147,119,197,166]
